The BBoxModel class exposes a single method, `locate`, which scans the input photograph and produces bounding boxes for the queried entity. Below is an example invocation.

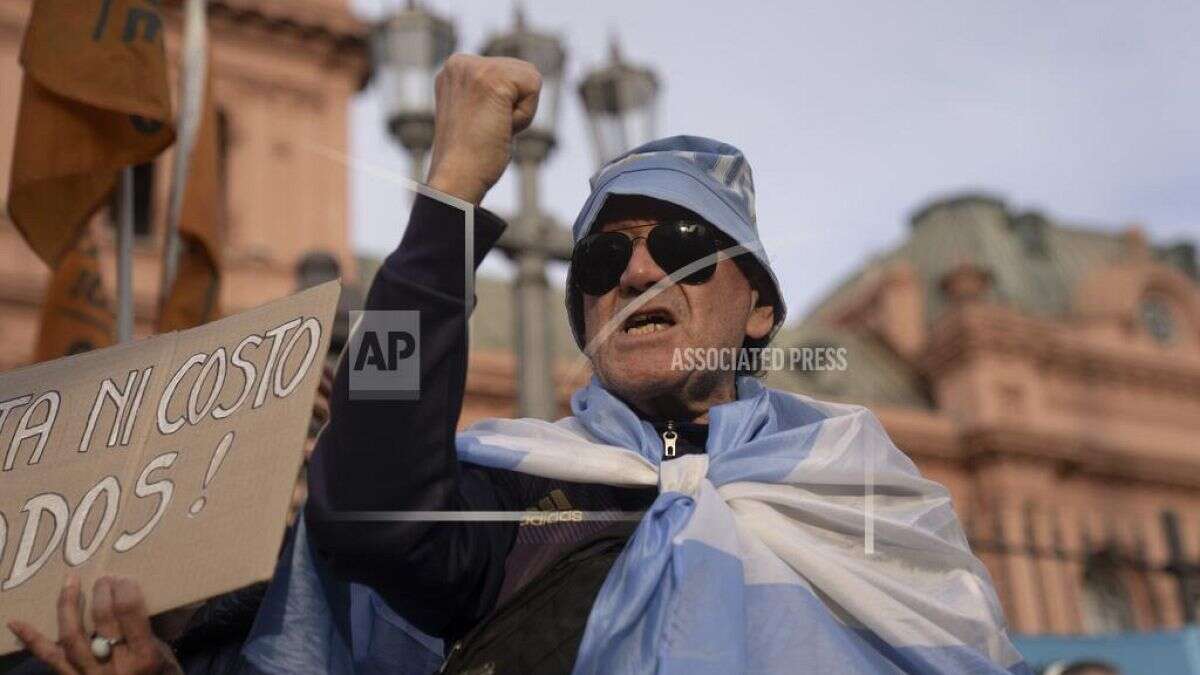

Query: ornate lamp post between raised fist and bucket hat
[482,8,571,419]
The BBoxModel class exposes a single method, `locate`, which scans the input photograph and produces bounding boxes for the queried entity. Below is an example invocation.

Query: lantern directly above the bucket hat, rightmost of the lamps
[580,37,659,168]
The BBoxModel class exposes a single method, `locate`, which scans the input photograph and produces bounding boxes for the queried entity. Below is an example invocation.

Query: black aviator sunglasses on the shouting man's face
[570,220,727,295]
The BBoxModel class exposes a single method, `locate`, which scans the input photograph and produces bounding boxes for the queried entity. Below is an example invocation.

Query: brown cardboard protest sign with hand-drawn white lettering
[0,281,341,655]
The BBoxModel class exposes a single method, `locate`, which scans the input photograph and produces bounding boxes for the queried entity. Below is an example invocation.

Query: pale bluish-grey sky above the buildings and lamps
[350,0,1200,319]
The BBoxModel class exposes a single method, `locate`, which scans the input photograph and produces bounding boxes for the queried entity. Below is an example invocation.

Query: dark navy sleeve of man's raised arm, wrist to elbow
[306,197,509,633]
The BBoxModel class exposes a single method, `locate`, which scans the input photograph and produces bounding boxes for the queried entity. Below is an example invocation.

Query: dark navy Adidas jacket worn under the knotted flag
[306,197,707,641]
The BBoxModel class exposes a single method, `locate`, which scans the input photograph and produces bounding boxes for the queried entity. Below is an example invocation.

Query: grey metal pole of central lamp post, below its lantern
[514,153,558,419]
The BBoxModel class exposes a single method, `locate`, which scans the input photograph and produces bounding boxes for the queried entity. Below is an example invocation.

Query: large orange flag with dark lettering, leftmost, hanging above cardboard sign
[7,0,174,360]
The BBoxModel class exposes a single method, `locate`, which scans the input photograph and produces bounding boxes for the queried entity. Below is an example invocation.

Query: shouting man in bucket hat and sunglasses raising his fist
[285,54,1024,674]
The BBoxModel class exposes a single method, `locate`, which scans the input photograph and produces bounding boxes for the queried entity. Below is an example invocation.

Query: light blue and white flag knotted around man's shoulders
[244,377,1031,675]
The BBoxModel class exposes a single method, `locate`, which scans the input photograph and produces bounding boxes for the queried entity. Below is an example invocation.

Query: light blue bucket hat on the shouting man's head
[566,136,787,350]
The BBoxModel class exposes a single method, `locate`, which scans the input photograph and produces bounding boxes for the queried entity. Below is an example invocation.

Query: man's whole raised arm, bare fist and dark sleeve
[306,49,541,637]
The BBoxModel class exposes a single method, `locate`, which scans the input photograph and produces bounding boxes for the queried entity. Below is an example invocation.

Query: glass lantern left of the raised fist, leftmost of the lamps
[371,0,458,183]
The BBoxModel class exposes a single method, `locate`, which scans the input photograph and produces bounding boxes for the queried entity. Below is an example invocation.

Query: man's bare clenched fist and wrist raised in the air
[427,54,541,204]
